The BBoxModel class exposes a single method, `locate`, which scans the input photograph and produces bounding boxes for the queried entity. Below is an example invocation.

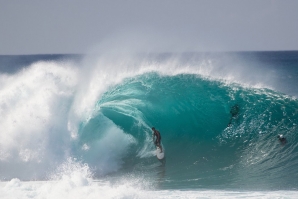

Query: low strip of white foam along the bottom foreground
[0,179,298,199]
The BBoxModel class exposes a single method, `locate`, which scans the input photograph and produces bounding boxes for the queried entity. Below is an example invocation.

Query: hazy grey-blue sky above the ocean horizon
[0,0,298,54]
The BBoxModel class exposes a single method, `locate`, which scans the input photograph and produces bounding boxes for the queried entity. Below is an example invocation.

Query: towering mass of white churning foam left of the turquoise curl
[0,62,77,179]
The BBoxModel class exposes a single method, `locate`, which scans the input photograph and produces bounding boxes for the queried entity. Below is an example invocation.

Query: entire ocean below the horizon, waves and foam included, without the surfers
[0,51,298,198]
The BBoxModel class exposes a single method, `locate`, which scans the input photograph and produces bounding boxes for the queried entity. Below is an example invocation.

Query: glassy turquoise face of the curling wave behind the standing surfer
[80,73,298,189]
